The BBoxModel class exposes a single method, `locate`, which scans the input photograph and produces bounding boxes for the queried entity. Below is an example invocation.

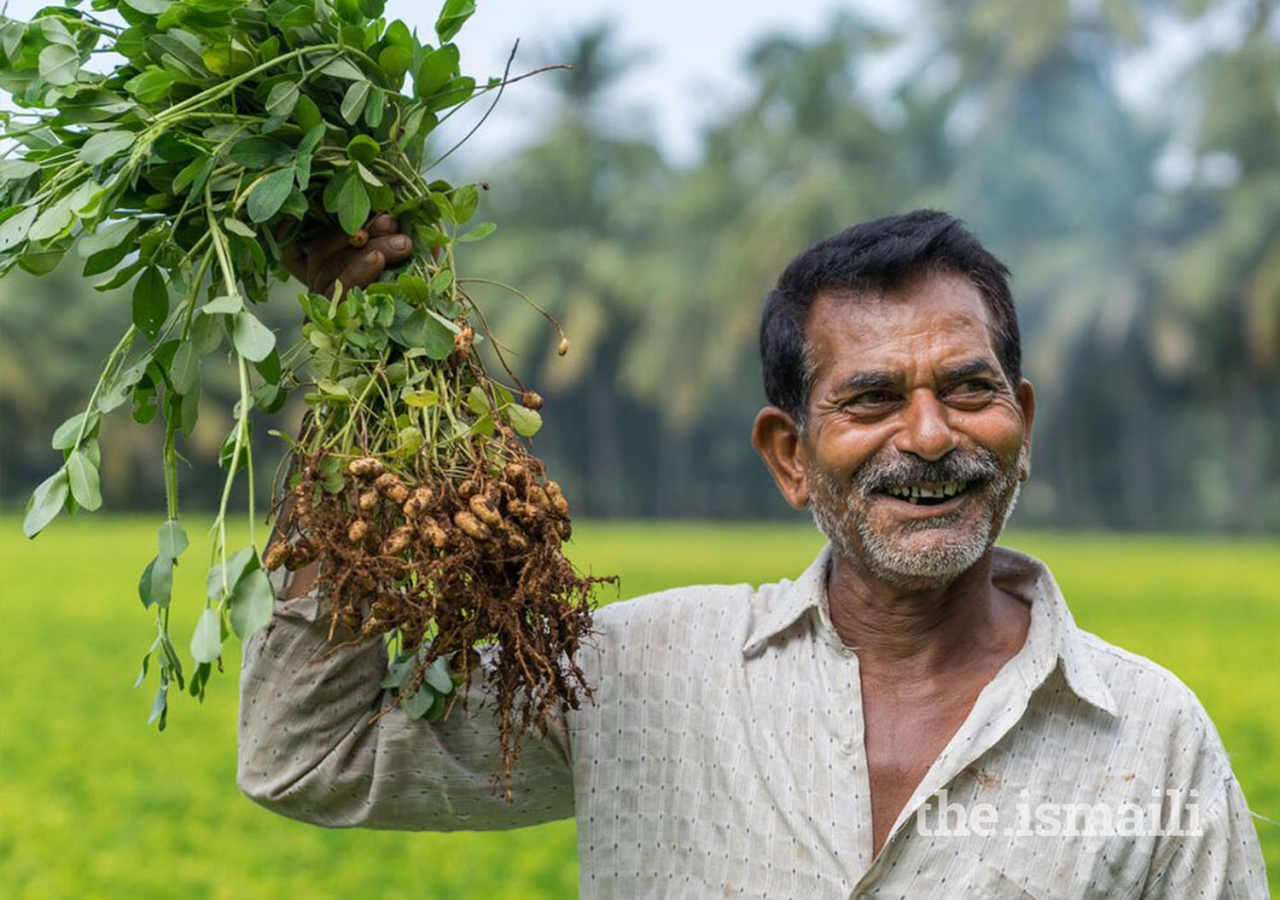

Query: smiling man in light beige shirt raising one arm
[239,211,1267,900]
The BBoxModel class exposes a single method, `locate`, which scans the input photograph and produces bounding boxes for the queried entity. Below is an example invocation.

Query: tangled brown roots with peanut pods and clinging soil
[264,434,617,800]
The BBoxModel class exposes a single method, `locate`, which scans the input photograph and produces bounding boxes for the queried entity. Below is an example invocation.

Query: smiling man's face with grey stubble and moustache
[800,275,1033,589]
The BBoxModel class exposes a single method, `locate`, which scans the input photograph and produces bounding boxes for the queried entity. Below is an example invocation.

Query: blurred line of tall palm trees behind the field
[0,0,1280,531]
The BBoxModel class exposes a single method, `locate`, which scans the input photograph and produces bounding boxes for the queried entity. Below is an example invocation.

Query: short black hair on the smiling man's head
[760,210,1023,429]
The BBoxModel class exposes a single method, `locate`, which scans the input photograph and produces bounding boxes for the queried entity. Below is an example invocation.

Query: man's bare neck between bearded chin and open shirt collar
[827,549,1029,679]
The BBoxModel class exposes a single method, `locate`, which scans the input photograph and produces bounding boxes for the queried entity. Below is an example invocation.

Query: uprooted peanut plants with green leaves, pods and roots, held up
[0,0,609,793]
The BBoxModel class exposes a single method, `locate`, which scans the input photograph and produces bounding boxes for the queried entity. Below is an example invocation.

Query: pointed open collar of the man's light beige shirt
[742,543,1116,716]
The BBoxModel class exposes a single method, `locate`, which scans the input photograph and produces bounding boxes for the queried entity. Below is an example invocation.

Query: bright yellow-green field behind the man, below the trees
[0,516,1280,900]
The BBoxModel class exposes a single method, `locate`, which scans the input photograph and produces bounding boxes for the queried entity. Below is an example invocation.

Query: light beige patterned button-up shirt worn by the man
[239,548,1267,900]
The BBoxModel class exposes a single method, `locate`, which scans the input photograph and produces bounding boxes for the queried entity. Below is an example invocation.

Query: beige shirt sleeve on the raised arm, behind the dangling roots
[237,577,573,831]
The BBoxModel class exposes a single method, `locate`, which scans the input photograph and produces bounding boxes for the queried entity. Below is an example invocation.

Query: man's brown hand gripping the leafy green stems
[283,213,413,297]
